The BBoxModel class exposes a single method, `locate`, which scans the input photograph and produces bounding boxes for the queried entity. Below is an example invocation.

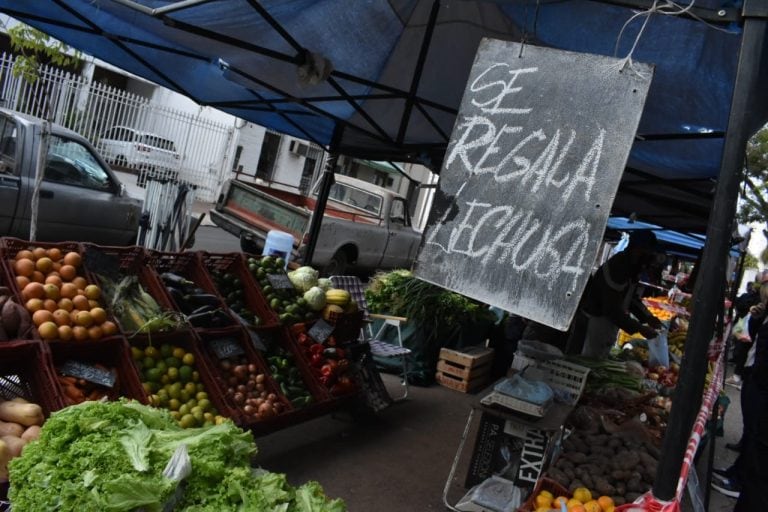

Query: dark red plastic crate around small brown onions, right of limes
[198,327,293,428]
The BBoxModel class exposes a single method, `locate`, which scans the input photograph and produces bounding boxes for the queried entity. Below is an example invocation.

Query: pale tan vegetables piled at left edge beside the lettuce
[0,398,45,482]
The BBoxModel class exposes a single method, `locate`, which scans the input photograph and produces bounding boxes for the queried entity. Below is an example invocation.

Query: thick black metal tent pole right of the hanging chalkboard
[653,0,768,501]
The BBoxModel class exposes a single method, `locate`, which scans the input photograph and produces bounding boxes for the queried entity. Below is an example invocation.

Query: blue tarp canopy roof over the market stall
[0,0,768,232]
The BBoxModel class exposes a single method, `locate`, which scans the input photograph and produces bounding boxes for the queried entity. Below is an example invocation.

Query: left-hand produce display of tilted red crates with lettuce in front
[0,237,370,510]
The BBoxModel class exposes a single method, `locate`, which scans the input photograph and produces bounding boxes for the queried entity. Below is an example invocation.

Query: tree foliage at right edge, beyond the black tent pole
[736,127,768,224]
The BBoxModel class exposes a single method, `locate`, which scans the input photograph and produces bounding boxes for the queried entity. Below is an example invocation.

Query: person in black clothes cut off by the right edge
[733,282,768,512]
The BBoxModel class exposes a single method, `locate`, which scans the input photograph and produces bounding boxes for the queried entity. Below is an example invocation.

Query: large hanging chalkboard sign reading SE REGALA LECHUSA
[415,39,652,330]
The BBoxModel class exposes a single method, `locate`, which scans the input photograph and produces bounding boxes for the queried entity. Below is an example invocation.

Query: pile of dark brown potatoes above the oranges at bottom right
[547,430,658,506]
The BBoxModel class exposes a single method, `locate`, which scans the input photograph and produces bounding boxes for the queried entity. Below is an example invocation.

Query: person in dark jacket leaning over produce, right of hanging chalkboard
[567,230,661,358]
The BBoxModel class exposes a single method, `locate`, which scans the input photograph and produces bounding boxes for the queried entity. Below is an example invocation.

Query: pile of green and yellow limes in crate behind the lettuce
[131,343,225,428]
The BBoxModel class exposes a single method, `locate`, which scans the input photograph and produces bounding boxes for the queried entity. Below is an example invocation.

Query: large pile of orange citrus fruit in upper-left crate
[10,247,117,341]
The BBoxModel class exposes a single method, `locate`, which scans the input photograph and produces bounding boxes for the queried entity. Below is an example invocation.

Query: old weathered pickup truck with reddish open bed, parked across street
[211,175,421,275]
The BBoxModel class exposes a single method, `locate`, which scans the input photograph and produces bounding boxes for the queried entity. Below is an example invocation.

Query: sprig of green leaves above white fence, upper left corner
[8,23,81,83]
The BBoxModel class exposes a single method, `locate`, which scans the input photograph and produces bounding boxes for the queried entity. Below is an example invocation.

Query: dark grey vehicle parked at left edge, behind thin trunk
[0,109,142,245]
